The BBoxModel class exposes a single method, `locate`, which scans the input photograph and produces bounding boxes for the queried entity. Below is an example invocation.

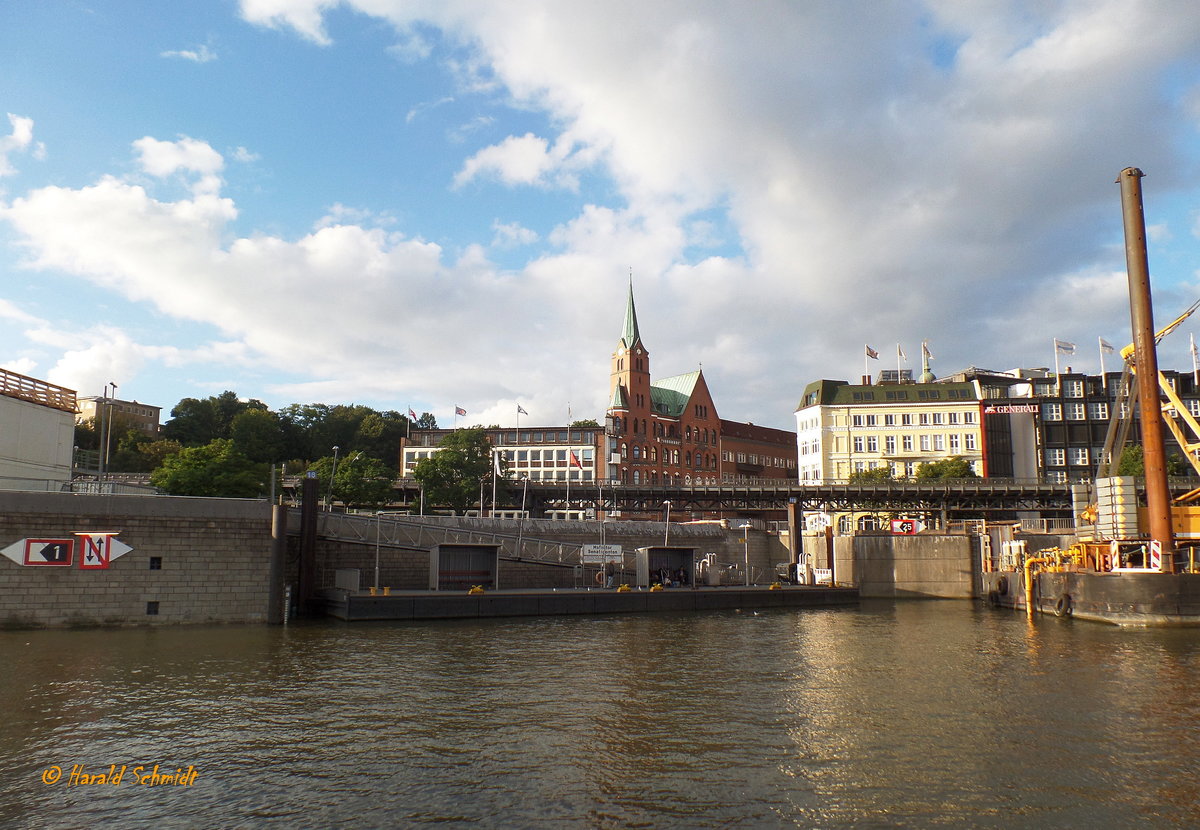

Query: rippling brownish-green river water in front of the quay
[0,602,1200,828]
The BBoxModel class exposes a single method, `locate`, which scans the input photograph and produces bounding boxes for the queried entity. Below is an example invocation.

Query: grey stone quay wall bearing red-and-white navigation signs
[0,492,271,627]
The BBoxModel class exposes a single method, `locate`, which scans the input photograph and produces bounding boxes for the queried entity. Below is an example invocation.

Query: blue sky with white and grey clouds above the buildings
[0,0,1200,429]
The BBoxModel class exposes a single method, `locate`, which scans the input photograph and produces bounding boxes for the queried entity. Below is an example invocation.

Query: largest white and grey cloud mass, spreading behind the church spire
[11,0,1200,426]
